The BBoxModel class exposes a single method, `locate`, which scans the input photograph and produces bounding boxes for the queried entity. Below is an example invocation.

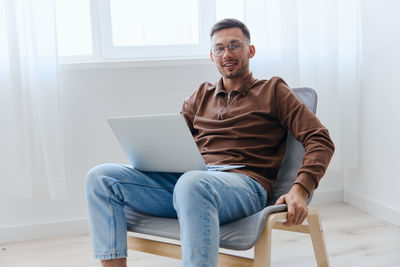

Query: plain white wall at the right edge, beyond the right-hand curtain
[344,0,400,226]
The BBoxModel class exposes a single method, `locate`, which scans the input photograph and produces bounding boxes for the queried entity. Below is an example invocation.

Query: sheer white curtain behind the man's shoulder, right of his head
[244,0,361,169]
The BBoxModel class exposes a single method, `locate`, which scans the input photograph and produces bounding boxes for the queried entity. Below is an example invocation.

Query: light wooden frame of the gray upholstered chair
[128,208,329,267]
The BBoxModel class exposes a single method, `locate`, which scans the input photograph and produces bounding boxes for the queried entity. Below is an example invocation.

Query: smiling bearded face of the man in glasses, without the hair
[210,28,255,79]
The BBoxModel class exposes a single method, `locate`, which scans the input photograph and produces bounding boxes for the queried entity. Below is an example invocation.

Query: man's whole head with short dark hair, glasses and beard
[210,19,255,79]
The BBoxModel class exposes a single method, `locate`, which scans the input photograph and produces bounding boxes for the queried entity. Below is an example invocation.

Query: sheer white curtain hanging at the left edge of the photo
[0,0,66,200]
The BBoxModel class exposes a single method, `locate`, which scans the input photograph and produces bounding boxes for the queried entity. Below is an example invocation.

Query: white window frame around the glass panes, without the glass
[60,0,216,63]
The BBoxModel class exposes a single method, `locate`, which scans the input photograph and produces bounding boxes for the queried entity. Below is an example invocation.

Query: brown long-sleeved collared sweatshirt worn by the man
[182,74,334,196]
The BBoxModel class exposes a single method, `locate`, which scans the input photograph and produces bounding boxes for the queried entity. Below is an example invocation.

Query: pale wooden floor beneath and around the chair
[0,203,400,267]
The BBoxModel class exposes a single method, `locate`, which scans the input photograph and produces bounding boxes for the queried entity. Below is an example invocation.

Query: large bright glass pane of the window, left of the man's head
[110,0,199,46]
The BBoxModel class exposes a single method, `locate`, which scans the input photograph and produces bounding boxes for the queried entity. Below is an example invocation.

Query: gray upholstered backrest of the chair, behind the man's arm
[268,87,317,205]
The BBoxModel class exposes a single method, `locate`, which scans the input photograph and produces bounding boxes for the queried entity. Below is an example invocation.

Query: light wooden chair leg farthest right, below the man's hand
[307,209,329,267]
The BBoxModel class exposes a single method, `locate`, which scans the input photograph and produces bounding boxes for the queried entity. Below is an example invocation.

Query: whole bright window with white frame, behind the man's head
[56,0,244,62]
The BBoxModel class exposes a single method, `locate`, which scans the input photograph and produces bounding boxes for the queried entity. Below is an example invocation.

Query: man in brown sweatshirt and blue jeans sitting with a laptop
[87,19,334,267]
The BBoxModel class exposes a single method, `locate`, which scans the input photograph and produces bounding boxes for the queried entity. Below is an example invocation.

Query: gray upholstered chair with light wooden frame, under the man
[125,88,329,267]
